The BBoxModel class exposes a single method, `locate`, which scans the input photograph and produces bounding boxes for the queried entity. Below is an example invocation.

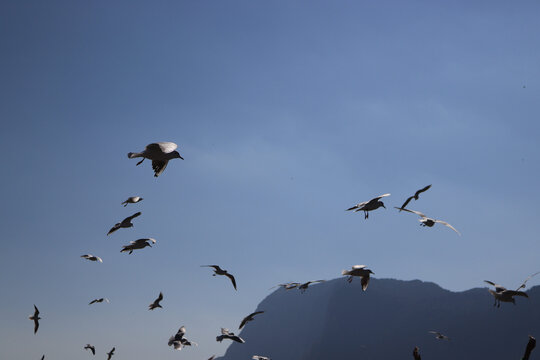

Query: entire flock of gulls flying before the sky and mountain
[29,142,540,360]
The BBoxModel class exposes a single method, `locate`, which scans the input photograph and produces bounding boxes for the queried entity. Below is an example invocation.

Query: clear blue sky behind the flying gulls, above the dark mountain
[0,0,540,360]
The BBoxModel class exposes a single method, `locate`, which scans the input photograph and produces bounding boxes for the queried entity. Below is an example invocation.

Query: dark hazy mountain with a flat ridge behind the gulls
[217,278,540,360]
